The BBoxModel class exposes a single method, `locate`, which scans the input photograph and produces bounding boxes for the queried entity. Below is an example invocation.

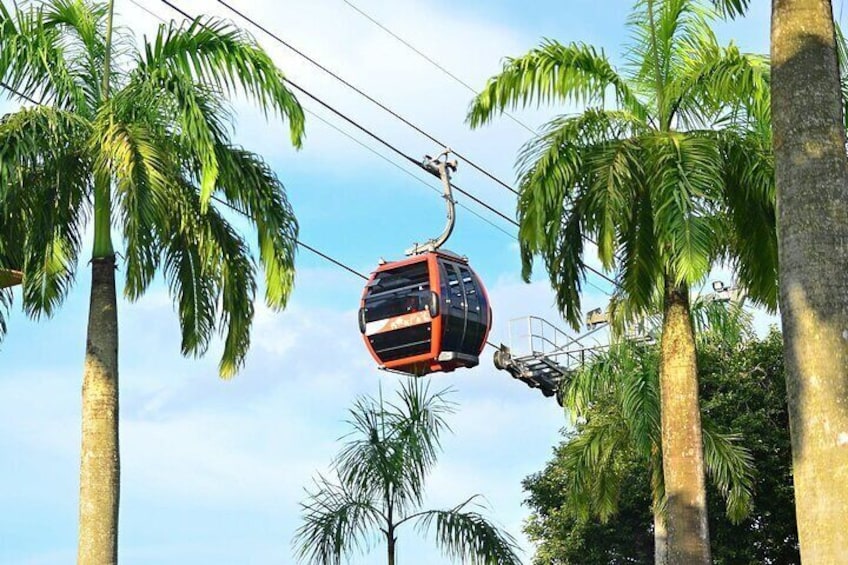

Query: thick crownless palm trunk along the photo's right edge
[771,0,848,563]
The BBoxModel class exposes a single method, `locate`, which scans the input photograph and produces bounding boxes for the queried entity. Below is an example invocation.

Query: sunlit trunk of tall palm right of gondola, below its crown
[660,277,710,565]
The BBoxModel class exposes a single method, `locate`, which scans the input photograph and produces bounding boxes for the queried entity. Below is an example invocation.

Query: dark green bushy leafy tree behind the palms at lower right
[524,331,800,565]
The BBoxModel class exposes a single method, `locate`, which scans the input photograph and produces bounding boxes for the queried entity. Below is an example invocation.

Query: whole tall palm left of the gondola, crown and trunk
[0,0,303,564]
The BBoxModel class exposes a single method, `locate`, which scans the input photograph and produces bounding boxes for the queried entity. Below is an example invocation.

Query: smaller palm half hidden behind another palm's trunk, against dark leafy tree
[560,299,753,565]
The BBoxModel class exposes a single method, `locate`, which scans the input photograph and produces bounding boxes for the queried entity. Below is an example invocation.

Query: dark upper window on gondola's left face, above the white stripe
[365,261,430,322]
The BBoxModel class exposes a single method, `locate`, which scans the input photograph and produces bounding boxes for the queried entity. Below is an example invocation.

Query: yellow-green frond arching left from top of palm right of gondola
[466,39,647,128]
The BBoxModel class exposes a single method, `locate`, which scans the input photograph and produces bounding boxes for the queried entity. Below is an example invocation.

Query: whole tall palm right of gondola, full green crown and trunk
[469,0,777,563]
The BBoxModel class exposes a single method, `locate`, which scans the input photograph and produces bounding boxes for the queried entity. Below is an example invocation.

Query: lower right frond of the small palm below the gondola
[416,502,521,565]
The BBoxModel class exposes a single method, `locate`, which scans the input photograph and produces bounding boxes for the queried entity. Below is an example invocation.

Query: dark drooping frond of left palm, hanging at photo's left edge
[0,107,91,317]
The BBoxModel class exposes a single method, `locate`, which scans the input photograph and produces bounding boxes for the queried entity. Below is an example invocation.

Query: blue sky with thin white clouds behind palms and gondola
[0,0,780,565]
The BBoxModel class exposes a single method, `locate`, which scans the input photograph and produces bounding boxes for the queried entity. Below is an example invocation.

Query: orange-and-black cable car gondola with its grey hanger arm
[359,151,492,376]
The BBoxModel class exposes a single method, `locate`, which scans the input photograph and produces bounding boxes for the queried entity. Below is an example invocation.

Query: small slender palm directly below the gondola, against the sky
[295,379,520,565]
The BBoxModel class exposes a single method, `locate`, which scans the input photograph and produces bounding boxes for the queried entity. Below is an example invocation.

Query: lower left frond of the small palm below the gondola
[293,477,384,565]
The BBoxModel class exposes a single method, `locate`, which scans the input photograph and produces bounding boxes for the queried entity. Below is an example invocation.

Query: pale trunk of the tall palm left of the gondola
[77,255,121,565]
